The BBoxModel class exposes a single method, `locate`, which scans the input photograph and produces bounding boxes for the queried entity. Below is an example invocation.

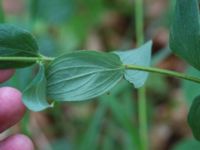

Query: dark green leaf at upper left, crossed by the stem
[0,24,38,69]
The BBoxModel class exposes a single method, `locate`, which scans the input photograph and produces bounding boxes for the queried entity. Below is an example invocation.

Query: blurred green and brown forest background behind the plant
[0,0,200,150]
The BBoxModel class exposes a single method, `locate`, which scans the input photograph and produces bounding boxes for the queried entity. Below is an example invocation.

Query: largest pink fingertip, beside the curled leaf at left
[0,87,26,133]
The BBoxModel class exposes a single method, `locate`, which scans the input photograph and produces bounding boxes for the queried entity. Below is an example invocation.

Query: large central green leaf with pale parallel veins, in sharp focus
[47,51,125,101]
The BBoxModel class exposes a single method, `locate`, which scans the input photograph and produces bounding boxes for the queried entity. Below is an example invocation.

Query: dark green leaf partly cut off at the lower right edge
[188,96,200,141]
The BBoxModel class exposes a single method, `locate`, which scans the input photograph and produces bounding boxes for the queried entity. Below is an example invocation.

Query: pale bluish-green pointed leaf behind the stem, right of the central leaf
[115,41,152,88]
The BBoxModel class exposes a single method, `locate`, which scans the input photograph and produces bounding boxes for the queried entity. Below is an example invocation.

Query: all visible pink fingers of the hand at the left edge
[0,70,34,150]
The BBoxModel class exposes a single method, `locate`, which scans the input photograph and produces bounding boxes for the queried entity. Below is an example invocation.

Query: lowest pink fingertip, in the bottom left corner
[0,134,34,150]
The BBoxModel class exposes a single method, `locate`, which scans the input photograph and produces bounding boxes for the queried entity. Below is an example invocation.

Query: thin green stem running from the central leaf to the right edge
[125,65,200,84]
